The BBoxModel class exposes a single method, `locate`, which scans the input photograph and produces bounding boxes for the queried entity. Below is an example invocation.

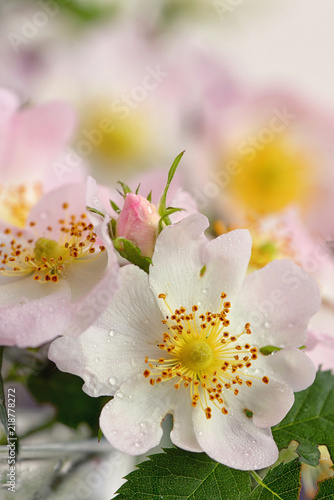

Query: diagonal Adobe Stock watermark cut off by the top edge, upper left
[7,0,71,53]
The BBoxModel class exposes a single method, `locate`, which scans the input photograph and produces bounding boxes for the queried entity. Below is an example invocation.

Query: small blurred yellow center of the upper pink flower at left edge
[0,183,43,227]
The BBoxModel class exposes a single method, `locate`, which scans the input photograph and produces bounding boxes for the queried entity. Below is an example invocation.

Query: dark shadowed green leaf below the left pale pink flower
[27,362,110,434]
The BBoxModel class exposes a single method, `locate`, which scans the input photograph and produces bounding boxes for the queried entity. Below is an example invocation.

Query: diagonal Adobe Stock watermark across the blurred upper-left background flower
[52,64,169,181]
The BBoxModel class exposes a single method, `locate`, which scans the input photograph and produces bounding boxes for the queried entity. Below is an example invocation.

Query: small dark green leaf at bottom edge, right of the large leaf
[249,458,301,500]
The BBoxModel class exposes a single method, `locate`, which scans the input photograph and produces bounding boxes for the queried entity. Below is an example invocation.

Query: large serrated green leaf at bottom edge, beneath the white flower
[116,448,251,500]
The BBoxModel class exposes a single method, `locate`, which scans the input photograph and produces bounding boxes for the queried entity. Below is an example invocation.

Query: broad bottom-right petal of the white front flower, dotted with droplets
[193,406,278,470]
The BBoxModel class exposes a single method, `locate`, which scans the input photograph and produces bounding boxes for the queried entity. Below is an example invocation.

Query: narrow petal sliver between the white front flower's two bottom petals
[170,388,203,452]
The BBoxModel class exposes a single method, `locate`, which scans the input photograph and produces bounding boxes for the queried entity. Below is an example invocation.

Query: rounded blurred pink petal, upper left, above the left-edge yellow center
[2,102,75,182]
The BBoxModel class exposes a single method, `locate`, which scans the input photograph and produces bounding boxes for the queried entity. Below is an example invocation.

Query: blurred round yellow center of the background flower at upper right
[229,138,312,215]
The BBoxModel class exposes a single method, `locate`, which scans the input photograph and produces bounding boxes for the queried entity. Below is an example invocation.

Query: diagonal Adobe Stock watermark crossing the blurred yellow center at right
[191,106,297,210]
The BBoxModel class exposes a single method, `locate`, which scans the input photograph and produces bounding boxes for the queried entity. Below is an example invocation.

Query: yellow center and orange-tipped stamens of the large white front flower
[143,293,269,419]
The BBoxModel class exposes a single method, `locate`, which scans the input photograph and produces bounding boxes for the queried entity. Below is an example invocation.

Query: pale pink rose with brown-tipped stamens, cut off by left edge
[0,183,118,347]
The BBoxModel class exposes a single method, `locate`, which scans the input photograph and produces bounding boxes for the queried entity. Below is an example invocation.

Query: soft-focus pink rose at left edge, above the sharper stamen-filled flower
[0,88,82,229]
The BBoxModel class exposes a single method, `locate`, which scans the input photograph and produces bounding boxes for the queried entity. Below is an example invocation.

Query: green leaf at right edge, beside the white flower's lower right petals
[272,371,334,466]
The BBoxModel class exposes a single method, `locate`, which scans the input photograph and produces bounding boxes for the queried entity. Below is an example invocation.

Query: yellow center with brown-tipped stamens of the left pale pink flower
[0,203,105,283]
